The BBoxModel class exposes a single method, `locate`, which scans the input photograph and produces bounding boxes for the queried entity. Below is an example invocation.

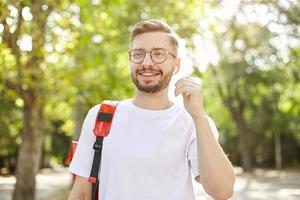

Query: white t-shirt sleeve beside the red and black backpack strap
[69,105,100,178]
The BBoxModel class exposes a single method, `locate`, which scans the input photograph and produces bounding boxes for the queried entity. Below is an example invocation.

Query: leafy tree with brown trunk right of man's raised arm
[202,1,299,171]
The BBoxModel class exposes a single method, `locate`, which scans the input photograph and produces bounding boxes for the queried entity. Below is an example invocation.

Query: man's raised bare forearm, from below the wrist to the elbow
[194,115,235,200]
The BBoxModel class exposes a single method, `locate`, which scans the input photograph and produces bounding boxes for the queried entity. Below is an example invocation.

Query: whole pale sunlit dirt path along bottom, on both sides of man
[0,168,300,200]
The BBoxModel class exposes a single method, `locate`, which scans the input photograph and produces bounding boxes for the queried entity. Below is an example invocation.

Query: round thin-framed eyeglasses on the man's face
[129,48,176,64]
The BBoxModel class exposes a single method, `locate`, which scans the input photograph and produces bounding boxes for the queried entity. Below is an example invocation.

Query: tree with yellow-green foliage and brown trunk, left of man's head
[0,0,206,200]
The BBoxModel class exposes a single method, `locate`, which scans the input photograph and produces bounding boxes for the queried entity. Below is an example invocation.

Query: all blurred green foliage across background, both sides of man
[0,0,300,173]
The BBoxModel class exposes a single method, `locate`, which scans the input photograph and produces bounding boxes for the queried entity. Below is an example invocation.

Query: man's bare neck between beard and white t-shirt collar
[133,88,173,110]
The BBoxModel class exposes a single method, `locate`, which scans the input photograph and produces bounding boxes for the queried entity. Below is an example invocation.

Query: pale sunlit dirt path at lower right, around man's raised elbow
[194,170,300,200]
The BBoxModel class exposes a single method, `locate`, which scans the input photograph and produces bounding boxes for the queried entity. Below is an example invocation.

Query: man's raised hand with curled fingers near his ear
[175,77,206,119]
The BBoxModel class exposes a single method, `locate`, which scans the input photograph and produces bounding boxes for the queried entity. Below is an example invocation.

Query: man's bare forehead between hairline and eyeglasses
[131,32,171,50]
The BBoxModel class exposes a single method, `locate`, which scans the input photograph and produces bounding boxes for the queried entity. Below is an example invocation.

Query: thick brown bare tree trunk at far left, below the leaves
[13,97,44,200]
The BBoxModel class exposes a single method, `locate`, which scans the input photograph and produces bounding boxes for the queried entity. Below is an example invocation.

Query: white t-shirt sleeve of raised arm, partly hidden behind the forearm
[188,116,219,178]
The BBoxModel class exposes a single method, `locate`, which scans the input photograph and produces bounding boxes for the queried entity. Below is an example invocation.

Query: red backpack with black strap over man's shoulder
[65,100,118,200]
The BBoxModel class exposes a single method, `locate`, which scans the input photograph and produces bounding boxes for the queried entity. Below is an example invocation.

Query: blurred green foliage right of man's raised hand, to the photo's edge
[203,1,300,166]
